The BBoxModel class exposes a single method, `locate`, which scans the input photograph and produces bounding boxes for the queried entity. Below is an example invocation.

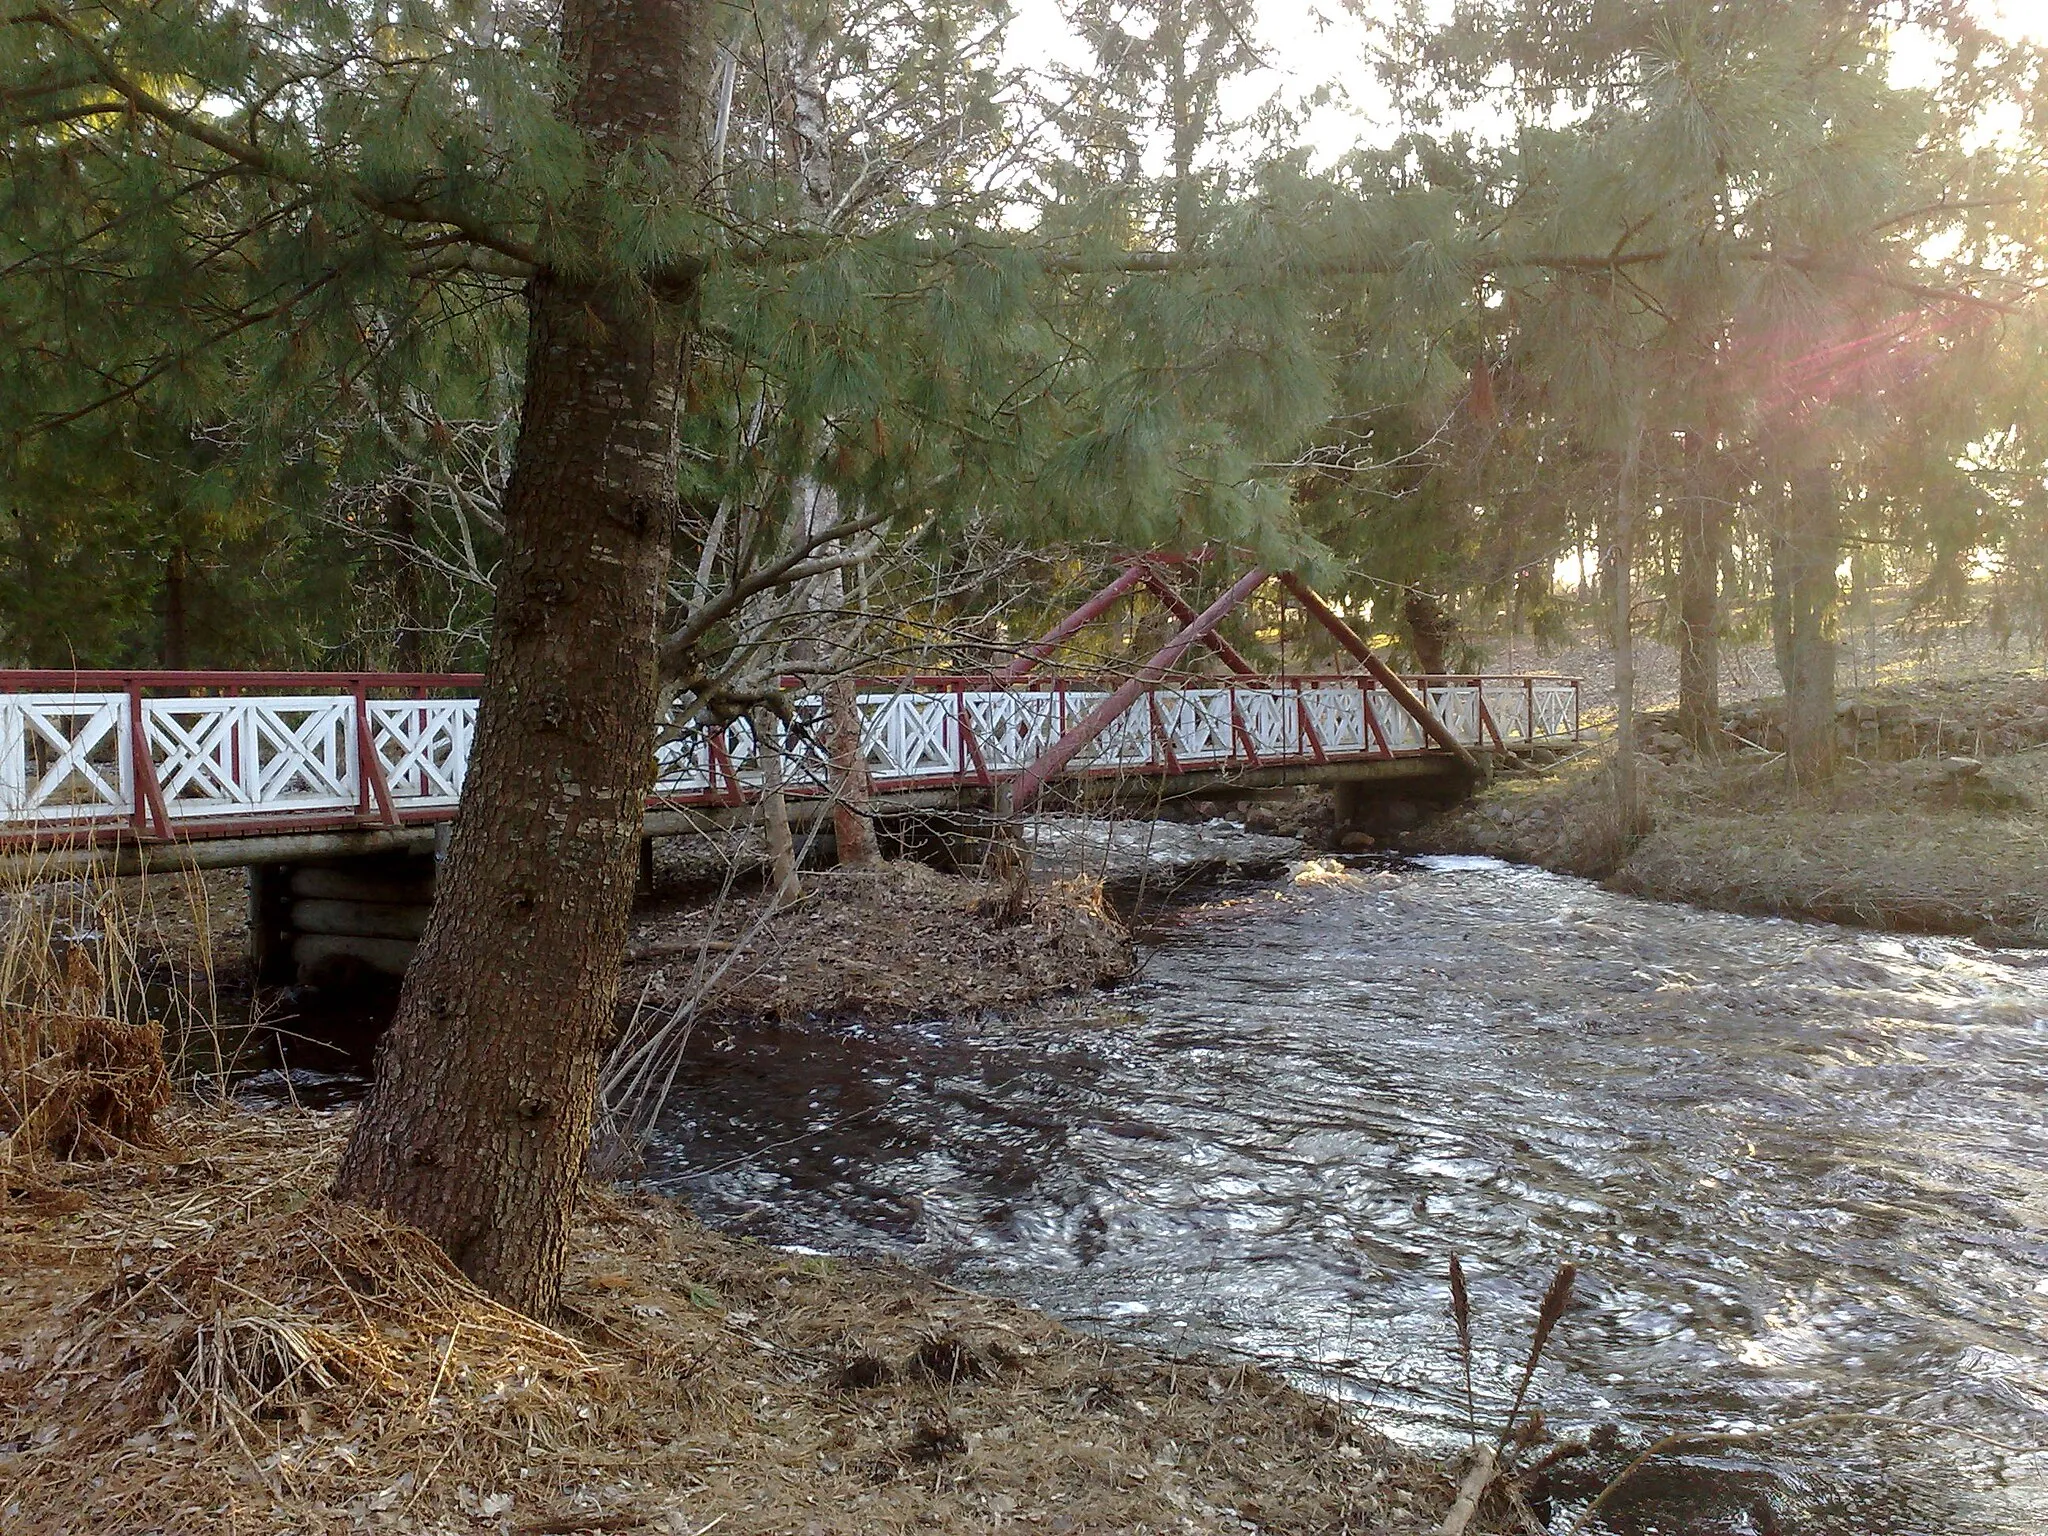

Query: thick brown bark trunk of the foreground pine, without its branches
[336,0,709,1315]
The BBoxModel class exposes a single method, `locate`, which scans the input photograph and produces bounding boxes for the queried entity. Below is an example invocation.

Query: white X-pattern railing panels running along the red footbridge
[0,672,1579,840]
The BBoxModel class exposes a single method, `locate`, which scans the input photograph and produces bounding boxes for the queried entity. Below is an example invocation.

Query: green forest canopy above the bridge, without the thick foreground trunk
[0,0,2048,757]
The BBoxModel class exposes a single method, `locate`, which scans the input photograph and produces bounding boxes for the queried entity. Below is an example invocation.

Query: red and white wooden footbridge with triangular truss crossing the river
[0,559,1579,870]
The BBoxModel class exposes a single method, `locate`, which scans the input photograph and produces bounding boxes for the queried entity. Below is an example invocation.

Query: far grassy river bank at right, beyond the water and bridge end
[1403,676,2048,944]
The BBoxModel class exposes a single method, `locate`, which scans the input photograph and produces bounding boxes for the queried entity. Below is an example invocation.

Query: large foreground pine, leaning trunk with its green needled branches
[0,0,1368,1311]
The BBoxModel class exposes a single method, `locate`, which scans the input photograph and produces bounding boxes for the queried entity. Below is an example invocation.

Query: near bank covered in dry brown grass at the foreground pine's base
[0,1108,1452,1536]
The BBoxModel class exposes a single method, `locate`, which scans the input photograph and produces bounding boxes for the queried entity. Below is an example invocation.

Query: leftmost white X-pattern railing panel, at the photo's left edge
[0,694,135,823]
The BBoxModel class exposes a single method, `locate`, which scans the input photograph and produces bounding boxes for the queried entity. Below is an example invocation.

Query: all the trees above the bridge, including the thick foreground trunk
[0,0,2048,1313]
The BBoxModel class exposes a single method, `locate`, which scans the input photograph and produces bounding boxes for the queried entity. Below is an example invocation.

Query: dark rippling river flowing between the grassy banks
[649,858,2048,1536]
